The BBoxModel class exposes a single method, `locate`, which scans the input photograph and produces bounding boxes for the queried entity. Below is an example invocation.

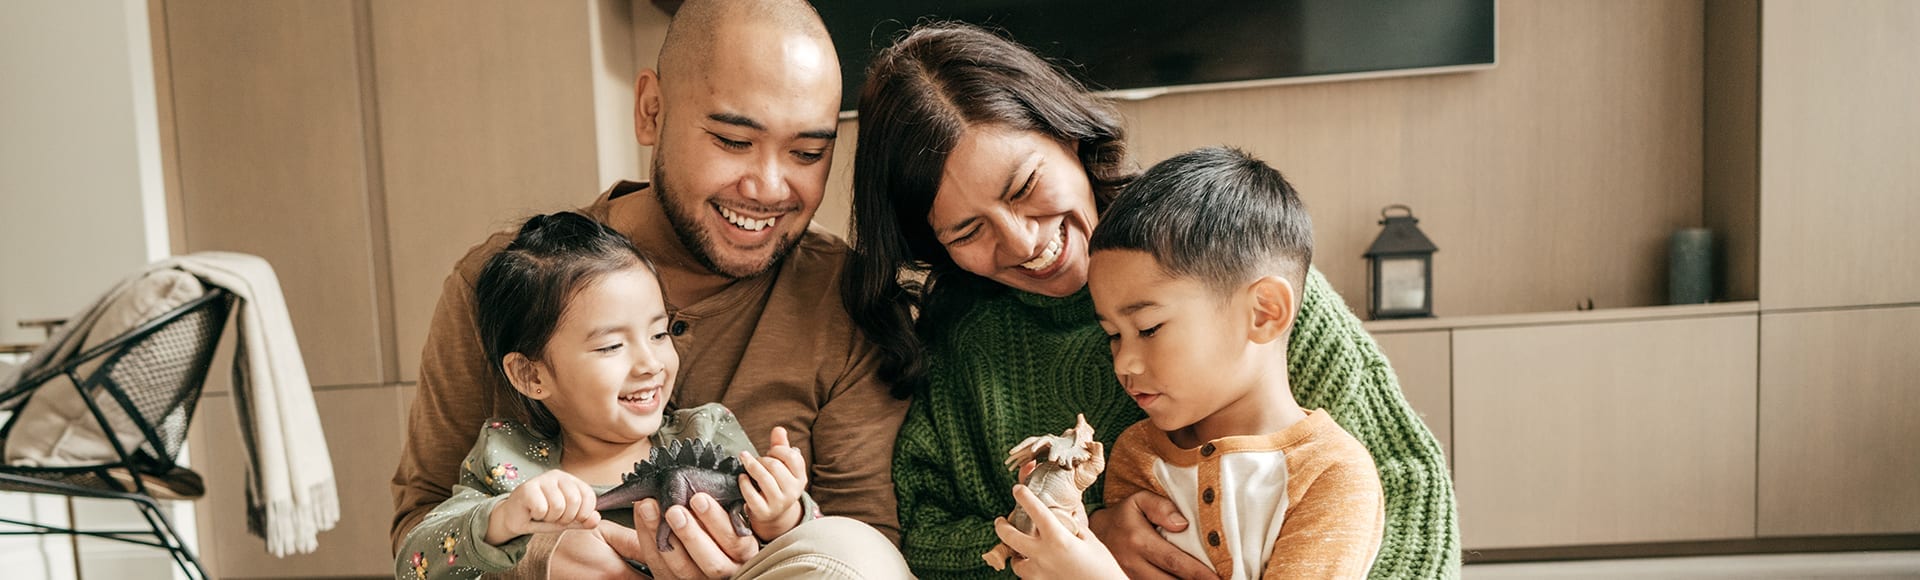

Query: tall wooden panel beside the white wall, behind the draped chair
[161,0,384,384]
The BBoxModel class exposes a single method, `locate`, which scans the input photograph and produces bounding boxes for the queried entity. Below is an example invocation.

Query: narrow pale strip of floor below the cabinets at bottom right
[1463,551,1920,580]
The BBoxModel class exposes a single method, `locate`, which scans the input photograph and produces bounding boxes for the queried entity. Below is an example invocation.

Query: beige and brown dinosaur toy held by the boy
[979,415,1106,570]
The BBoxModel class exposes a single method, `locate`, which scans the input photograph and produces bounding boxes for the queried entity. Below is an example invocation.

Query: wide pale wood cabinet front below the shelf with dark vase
[1453,315,1759,549]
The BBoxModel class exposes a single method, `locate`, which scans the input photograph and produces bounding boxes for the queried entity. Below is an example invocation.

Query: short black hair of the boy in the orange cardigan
[1087,148,1313,292]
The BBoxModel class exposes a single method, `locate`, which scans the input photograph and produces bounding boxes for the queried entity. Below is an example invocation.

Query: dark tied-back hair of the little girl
[474,211,660,436]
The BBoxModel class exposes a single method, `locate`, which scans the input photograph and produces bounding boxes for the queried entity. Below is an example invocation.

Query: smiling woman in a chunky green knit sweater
[841,23,1459,578]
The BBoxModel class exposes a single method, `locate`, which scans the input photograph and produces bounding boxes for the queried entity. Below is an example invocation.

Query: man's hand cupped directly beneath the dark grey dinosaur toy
[609,494,760,578]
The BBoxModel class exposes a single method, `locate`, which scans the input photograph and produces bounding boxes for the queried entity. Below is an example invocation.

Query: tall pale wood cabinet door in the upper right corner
[1761,0,1920,309]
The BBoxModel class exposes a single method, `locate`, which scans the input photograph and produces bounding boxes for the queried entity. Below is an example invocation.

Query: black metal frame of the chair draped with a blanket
[0,286,232,578]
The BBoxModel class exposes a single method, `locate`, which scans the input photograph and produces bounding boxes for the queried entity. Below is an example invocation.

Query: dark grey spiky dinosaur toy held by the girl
[593,440,753,551]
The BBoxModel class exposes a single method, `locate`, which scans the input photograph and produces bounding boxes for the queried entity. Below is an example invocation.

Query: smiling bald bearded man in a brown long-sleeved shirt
[392,0,906,578]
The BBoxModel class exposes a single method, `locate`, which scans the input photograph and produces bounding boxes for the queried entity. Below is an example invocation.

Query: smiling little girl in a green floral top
[394,211,818,578]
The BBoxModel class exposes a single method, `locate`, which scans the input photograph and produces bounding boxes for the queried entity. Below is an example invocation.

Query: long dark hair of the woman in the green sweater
[841,23,1139,398]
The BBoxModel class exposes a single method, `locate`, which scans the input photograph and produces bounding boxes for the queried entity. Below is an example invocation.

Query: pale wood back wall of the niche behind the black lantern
[1121,0,1704,317]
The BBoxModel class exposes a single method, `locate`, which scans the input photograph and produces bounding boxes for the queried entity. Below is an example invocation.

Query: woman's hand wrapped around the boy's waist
[1087,492,1219,580]
